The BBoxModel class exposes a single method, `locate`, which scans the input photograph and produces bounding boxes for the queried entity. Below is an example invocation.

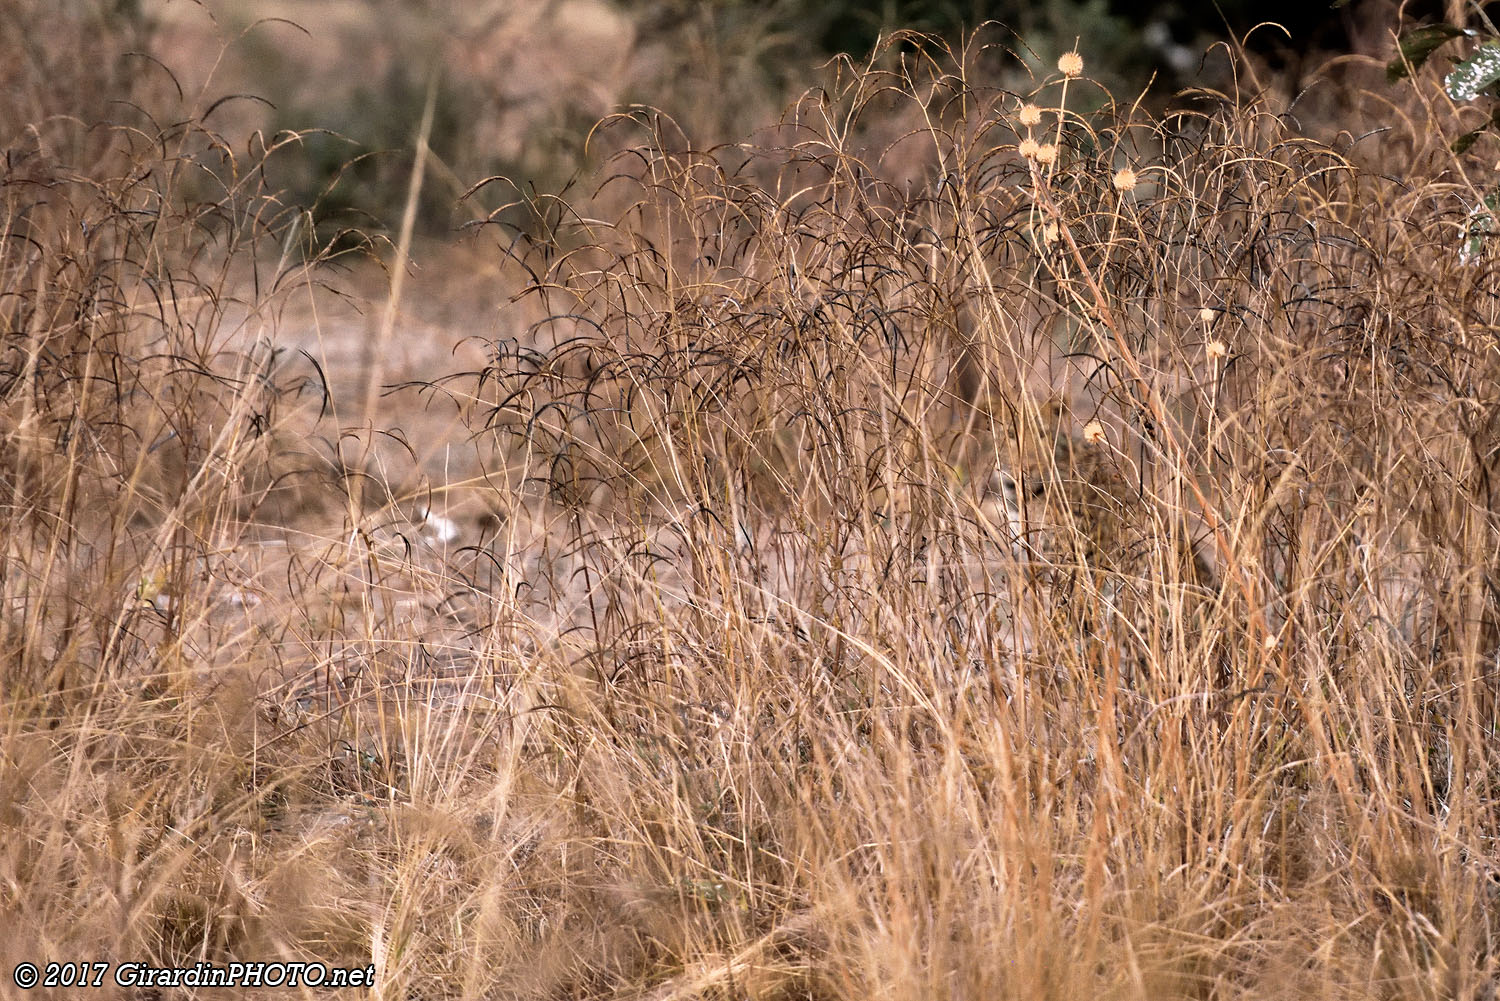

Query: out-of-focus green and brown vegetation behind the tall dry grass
[0,0,1442,239]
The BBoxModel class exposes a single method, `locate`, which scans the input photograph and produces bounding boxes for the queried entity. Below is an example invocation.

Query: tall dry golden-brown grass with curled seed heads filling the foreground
[0,15,1500,1001]
